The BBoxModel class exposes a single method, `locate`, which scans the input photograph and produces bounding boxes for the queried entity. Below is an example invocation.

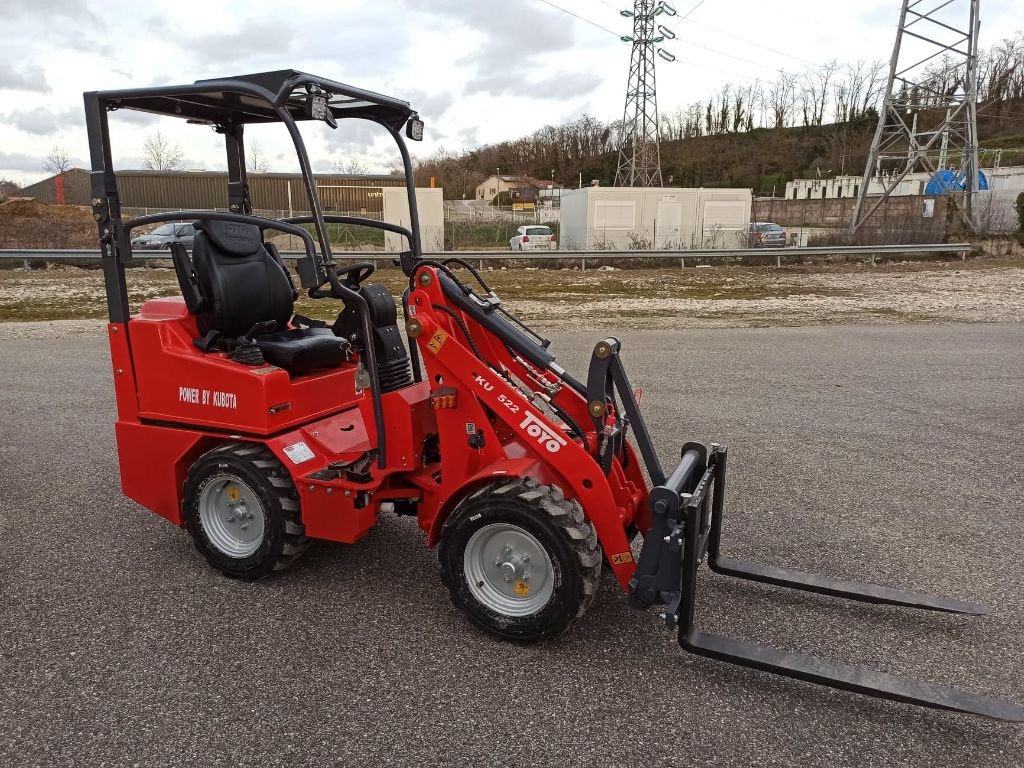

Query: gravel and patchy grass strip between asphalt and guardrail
[0,257,1024,338]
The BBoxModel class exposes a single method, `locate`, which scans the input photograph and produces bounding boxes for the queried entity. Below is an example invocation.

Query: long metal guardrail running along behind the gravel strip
[0,243,971,269]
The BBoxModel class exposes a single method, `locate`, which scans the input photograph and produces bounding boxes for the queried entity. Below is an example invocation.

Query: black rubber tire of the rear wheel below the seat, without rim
[181,442,309,580]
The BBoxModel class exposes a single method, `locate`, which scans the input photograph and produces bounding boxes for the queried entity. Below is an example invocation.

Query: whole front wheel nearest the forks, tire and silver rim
[438,478,601,641]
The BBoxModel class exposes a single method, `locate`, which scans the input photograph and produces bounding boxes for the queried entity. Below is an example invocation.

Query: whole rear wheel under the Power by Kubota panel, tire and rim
[182,442,309,579]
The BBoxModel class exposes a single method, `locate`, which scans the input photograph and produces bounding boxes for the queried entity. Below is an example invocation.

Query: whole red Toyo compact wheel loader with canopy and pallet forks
[85,71,1024,720]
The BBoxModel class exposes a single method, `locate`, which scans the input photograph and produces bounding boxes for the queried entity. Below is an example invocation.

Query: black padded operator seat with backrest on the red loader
[182,221,347,375]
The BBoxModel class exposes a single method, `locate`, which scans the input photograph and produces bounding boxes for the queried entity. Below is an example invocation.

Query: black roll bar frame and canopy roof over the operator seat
[83,70,423,475]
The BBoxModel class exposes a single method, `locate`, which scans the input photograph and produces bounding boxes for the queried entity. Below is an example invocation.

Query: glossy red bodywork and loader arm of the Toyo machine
[110,269,649,588]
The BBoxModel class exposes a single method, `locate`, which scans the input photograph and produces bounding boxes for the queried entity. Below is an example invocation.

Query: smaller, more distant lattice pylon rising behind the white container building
[615,0,675,186]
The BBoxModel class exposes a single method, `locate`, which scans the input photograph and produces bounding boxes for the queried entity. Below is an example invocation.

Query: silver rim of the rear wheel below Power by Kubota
[199,474,266,559]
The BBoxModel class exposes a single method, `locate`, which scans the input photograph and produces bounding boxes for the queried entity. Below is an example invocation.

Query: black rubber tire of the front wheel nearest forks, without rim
[437,477,601,642]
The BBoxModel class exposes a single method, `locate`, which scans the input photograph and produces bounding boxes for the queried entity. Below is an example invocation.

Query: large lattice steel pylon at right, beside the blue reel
[851,0,980,232]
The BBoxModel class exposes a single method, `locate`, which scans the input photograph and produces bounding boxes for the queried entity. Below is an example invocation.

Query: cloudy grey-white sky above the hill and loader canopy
[0,0,1024,183]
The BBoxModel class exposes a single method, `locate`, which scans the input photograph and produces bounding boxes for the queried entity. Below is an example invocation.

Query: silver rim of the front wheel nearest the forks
[463,522,555,616]
